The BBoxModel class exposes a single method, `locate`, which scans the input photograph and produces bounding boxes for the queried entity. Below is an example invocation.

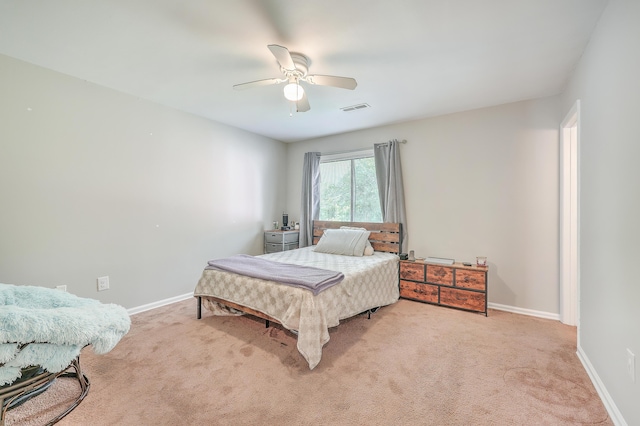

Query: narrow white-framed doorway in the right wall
[560,100,580,328]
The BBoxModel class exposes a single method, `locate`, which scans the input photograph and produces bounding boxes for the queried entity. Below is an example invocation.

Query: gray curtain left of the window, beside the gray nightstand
[300,152,320,247]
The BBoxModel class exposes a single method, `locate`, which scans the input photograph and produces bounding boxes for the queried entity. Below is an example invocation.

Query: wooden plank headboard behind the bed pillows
[313,220,402,254]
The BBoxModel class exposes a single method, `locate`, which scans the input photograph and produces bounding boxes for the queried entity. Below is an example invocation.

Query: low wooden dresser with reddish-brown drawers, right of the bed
[400,260,488,316]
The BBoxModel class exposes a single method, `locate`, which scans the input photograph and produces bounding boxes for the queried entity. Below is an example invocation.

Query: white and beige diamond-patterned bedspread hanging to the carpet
[194,247,399,369]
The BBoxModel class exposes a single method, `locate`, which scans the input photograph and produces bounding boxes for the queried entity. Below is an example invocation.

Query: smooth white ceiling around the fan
[0,0,607,142]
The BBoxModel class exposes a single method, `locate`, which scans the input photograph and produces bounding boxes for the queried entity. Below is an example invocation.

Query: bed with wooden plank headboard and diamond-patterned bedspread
[194,221,402,369]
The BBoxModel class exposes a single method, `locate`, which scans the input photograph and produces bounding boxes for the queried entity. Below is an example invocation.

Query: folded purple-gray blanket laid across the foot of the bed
[205,254,344,295]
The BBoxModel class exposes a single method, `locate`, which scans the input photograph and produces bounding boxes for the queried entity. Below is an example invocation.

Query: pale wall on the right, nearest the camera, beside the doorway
[563,0,640,425]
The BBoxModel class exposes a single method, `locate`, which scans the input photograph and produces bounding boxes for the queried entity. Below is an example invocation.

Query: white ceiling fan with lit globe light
[233,44,358,112]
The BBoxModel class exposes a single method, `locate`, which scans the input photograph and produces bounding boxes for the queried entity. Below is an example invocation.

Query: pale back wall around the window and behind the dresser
[287,97,561,317]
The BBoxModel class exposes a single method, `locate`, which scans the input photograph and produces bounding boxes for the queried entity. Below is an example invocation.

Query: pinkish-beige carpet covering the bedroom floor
[7,300,612,426]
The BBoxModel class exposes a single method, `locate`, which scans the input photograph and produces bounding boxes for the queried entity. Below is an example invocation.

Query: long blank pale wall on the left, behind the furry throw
[0,56,286,308]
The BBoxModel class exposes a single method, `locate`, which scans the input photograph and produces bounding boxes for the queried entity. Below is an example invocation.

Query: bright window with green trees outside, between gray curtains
[320,150,382,222]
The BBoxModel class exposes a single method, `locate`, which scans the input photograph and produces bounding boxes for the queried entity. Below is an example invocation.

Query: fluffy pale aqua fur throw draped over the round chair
[0,284,131,386]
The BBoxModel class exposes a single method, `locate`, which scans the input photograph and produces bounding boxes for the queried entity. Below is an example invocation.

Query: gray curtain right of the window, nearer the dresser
[373,140,408,252]
